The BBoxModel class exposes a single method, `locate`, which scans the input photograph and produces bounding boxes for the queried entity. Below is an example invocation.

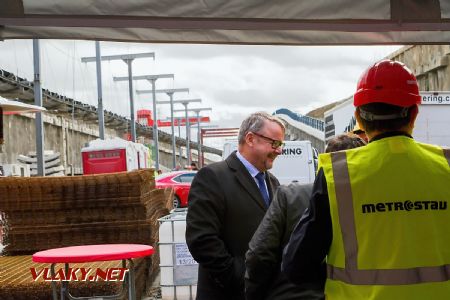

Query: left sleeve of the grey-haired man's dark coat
[186,167,245,288]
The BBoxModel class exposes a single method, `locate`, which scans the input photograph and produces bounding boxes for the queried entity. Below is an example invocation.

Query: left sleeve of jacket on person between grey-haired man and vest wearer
[245,187,286,300]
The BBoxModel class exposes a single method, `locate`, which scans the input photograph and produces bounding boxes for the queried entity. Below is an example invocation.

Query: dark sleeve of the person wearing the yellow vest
[281,169,332,283]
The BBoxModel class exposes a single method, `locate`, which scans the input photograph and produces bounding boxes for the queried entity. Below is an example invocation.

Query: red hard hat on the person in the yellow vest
[353,60,421,107]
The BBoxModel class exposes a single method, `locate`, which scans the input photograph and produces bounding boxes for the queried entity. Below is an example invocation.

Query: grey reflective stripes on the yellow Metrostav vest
[327,149,450,285]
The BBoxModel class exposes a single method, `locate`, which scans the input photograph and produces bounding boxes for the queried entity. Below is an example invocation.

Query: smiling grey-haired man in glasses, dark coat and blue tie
[186,112,285,300]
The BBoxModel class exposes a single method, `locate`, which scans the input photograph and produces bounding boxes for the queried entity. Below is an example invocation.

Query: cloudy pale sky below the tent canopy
[0,40,400,146]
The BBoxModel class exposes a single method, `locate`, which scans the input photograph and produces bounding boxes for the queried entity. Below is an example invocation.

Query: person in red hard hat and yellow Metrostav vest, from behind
[282,60,450,300]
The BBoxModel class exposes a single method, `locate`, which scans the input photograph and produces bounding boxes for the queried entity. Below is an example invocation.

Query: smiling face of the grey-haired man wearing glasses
[246,120,284,172]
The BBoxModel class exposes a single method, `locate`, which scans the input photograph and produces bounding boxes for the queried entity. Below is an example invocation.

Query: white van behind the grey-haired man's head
[222,140,317,184]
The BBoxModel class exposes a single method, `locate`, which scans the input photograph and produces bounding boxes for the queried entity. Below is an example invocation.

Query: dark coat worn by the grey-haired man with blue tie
[186,152,279,300]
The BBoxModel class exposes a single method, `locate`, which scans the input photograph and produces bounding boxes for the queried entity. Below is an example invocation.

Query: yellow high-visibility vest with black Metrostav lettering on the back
[319,136,450,300]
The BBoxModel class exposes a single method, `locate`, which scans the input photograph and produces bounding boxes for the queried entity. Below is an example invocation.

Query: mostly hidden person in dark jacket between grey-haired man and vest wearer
[245,134,365,300]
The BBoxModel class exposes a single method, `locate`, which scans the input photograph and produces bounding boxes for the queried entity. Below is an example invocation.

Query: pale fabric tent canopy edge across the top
[0,0,450,45]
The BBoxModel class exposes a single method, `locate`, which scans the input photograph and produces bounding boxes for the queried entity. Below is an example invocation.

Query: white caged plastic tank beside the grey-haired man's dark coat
[158,209,198,300]
